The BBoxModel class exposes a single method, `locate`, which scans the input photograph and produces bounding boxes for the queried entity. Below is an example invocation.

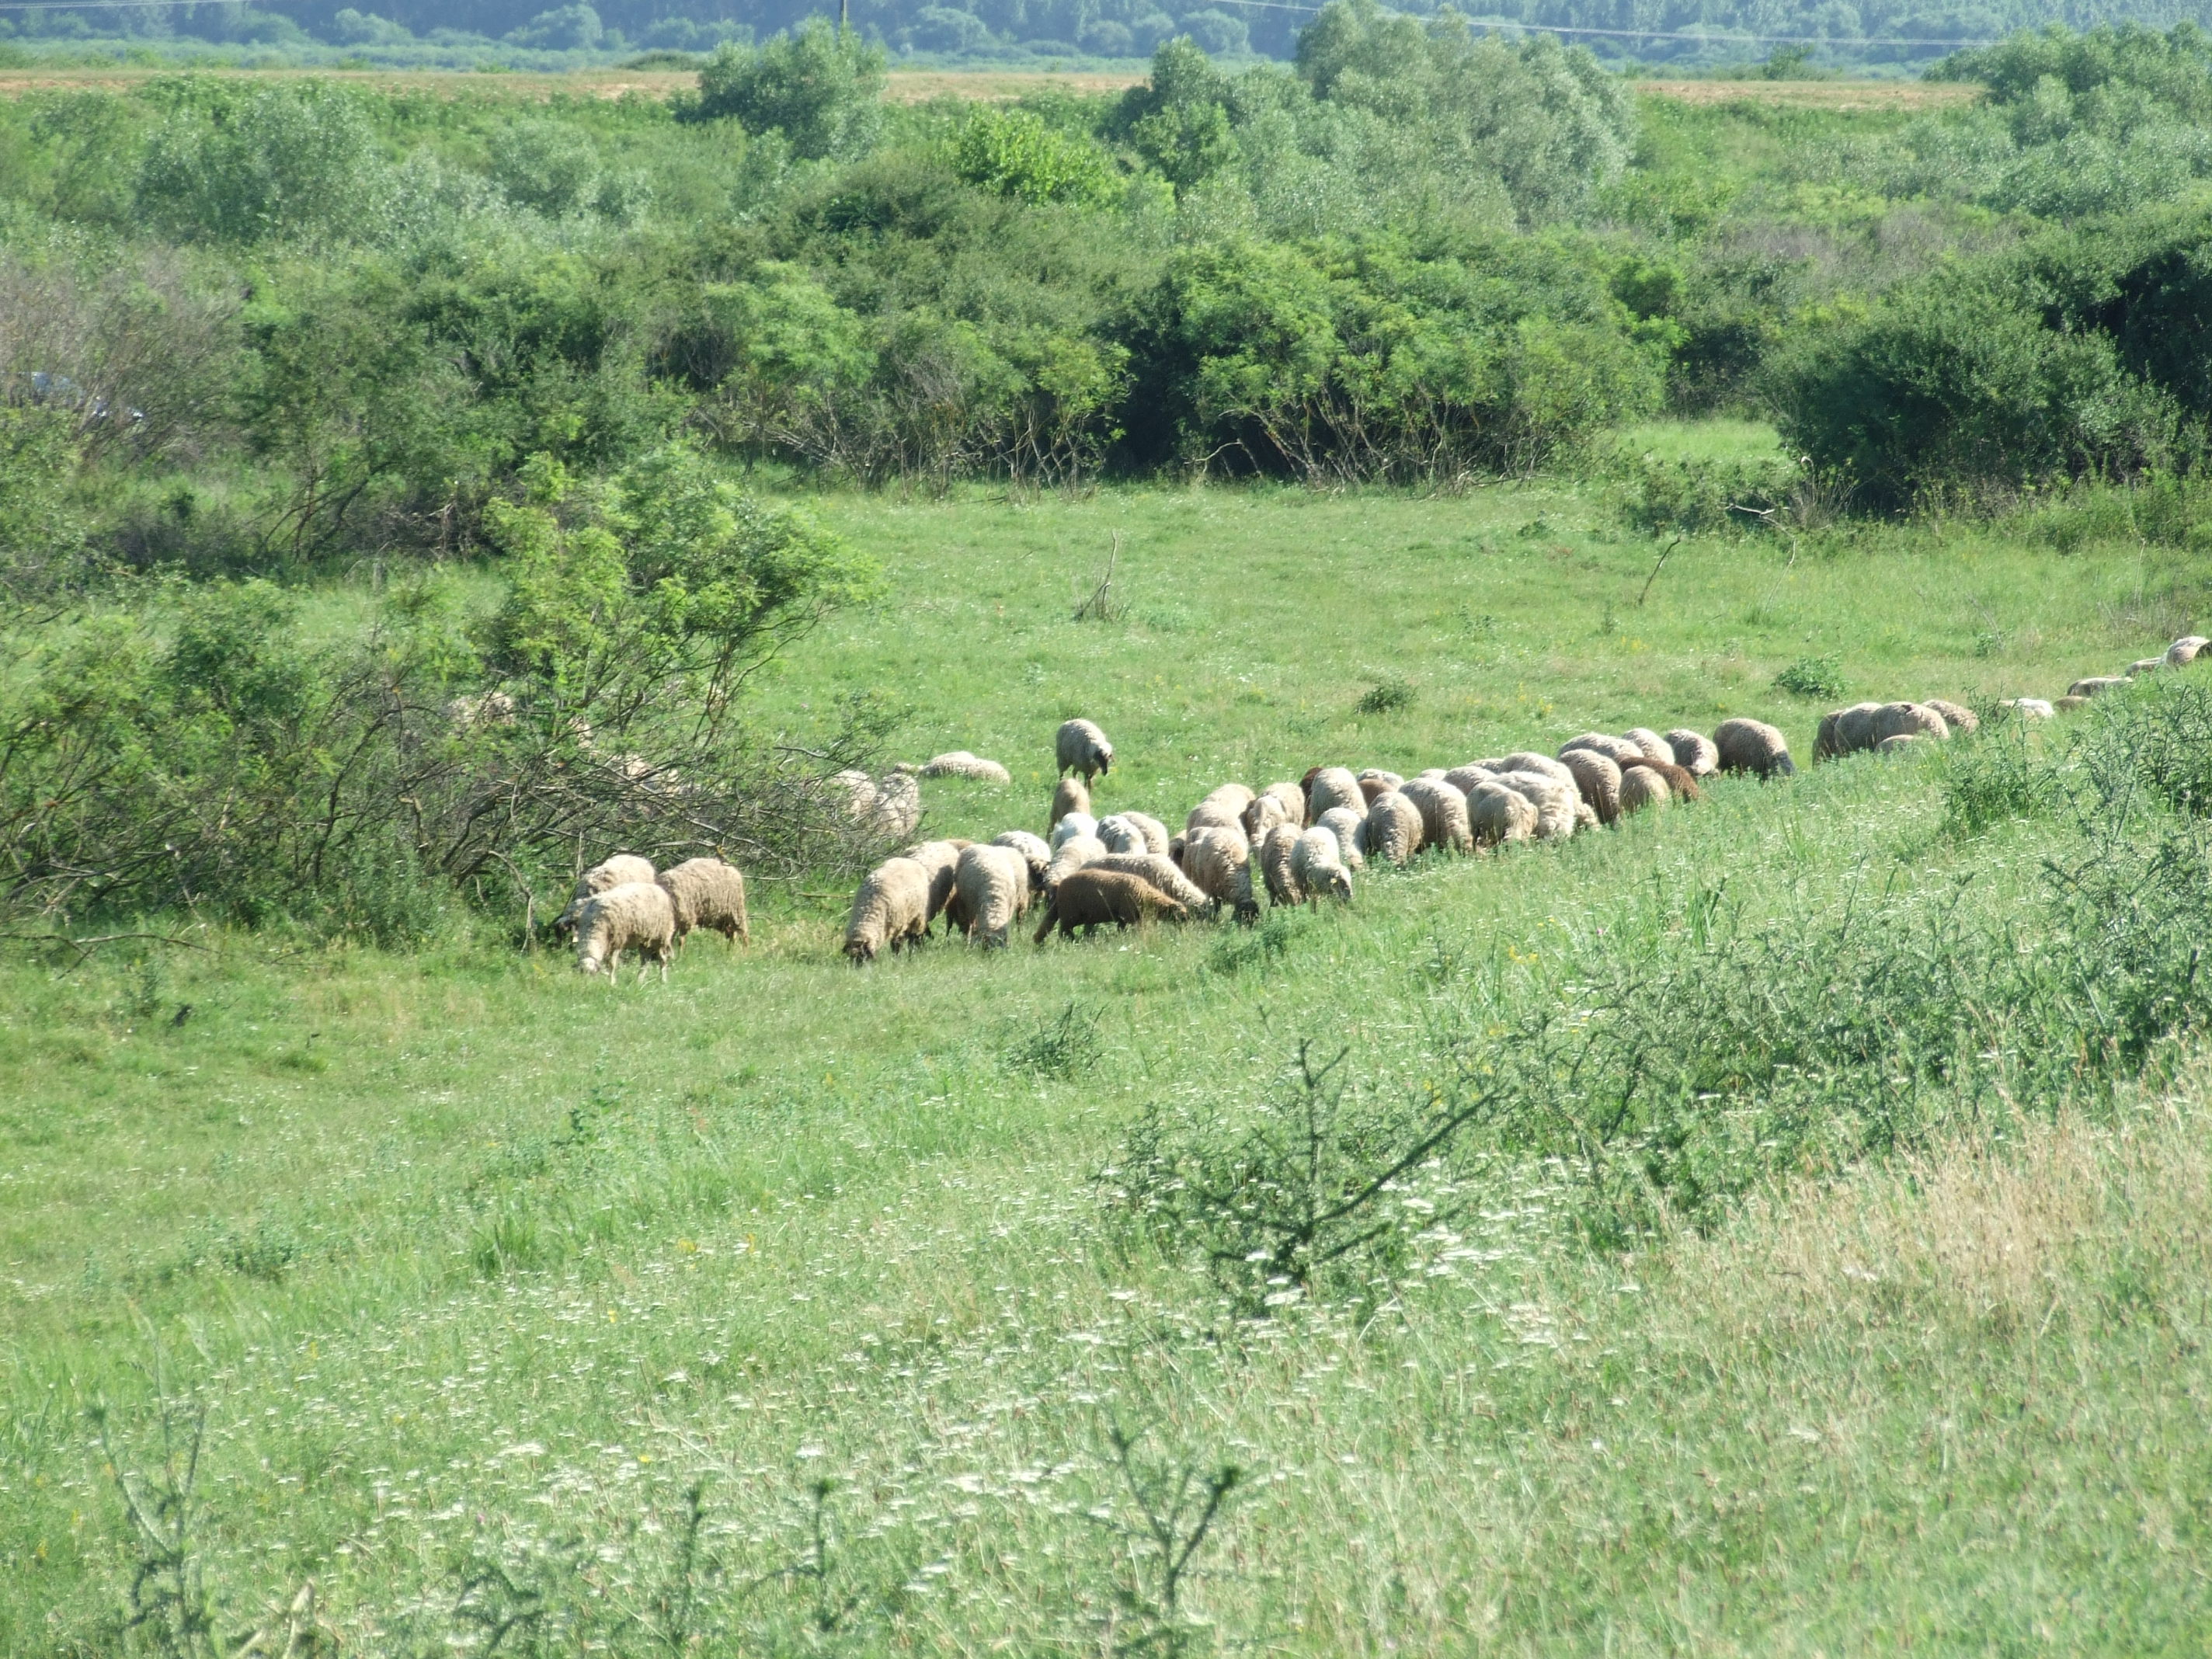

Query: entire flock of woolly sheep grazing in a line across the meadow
[560,635,2212,980]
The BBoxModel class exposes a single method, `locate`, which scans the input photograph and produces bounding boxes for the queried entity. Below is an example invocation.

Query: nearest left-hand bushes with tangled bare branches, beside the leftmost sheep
[0,449,876,938]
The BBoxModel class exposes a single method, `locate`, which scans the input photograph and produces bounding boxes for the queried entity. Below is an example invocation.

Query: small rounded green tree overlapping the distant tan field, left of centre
[697,18,885,159]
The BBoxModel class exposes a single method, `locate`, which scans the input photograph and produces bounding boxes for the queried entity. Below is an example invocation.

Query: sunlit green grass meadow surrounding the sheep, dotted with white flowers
[12,449,2212,1654]
